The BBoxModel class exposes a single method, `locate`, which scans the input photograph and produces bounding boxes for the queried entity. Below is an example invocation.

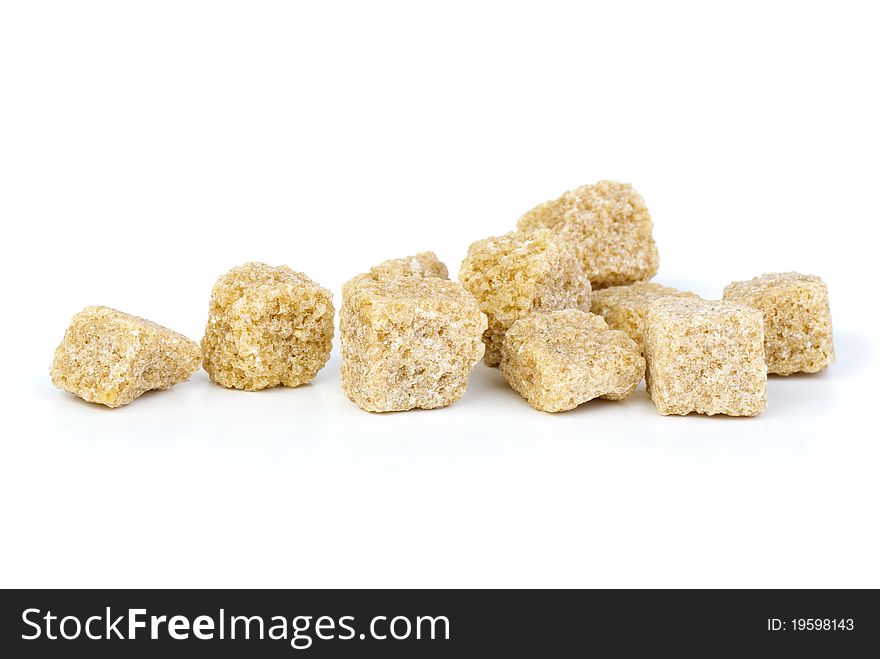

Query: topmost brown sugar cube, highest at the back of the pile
[517,181,660,289]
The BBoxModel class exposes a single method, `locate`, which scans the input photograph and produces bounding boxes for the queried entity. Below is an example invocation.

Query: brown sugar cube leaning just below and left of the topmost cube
[458,229,591,366]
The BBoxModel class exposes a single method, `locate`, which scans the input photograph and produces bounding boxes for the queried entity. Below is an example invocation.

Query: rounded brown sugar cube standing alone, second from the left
[202,263,334,391]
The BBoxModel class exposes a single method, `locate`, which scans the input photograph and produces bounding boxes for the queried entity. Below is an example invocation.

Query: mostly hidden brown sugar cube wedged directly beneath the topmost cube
[590,281,699,350]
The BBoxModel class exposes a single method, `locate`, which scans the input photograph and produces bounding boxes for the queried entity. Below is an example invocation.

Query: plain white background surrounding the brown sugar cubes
[0,1,880,587]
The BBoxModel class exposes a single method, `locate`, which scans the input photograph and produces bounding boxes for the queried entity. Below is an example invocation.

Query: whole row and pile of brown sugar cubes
[51,181,834,416]
